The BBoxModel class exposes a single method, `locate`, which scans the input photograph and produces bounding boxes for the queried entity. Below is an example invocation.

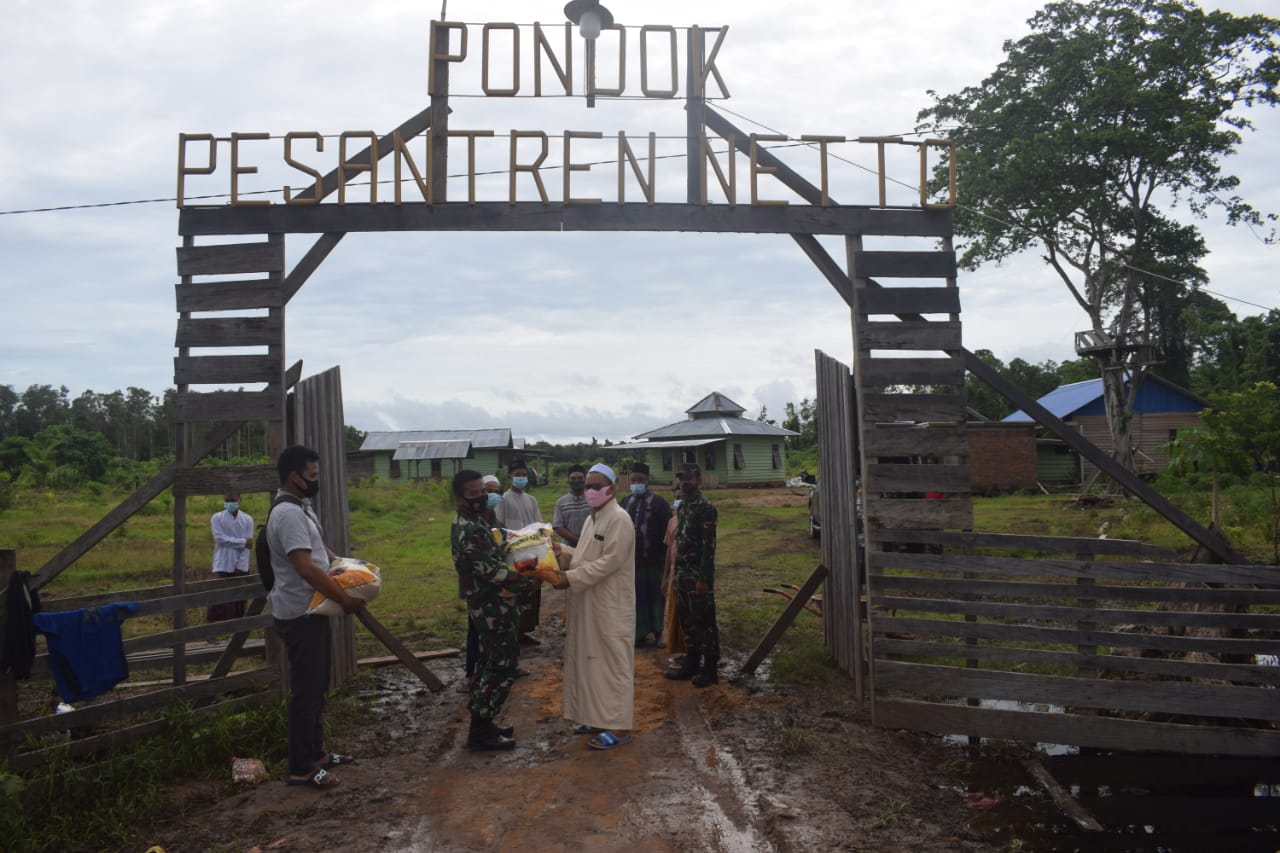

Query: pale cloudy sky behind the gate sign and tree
[0,0,1280,442]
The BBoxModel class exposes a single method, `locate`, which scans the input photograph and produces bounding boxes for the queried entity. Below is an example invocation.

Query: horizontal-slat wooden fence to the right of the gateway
[868,530,1280,756]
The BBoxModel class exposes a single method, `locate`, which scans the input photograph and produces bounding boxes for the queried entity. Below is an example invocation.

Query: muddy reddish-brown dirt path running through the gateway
[147,596,988,853]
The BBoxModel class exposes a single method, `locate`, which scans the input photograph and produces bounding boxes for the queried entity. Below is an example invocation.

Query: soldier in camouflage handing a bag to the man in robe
[449,470,536,749]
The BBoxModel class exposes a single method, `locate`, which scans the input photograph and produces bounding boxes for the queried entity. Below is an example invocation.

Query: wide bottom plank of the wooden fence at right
[876,699,1280,758]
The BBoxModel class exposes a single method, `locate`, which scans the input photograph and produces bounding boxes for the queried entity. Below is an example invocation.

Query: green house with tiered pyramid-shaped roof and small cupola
[609,392,797,488]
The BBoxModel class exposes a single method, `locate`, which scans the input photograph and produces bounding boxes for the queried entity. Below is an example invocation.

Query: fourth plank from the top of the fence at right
[876,596,1280,631]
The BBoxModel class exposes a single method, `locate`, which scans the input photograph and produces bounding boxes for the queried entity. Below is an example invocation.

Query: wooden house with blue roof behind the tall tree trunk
[1002,374,1208,483]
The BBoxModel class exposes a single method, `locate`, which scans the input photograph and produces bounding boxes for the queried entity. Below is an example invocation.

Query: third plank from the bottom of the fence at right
[876,637,1280,686]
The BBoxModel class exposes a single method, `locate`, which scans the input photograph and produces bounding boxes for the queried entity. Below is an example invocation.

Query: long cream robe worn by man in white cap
[564,501,636,730]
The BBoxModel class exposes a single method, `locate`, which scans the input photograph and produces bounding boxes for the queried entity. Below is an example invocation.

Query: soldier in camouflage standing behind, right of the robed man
[666,465,719,686]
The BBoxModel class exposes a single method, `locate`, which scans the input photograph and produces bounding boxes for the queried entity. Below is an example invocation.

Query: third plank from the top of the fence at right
[869,571,1280,604]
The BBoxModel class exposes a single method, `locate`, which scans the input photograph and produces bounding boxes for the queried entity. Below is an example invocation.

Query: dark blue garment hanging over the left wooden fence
[32,602,138,702]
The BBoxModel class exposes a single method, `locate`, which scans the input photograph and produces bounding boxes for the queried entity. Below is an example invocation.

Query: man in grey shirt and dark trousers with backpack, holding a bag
[265,444,364,788]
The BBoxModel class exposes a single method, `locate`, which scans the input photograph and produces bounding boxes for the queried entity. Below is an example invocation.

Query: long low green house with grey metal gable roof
[360,429,524,483]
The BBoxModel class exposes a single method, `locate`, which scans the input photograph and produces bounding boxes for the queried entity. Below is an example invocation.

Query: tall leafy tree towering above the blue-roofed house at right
[919,0,1280,469]
